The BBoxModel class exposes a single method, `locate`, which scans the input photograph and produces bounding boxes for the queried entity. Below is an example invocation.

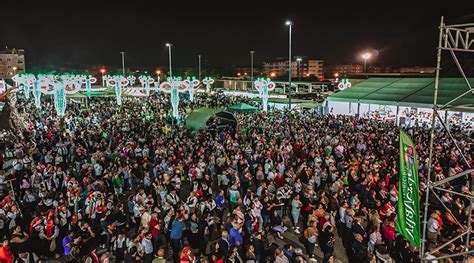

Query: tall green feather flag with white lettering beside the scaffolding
[395,130,420,248]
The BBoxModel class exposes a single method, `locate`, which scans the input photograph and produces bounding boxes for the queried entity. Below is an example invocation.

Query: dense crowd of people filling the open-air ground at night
[0,89,473,263]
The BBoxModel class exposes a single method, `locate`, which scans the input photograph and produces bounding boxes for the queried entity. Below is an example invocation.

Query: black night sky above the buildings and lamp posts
[0,1,474,72]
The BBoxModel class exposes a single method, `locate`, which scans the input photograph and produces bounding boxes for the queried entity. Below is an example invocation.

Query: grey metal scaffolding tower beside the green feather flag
[420,17,474,262]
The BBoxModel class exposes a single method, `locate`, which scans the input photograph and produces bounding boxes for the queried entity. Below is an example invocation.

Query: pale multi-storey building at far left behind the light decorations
[0,49,25,79]
